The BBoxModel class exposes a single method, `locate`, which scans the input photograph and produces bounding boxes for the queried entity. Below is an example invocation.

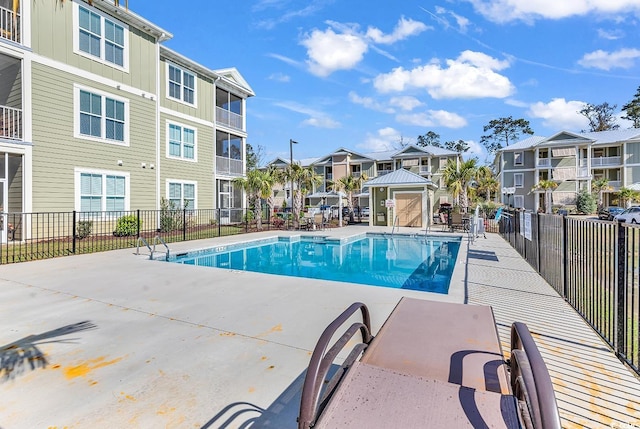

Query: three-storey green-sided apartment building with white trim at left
[0,0,254,238]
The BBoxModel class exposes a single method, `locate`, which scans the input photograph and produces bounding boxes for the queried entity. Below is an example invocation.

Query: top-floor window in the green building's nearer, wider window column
[73,3,129,70]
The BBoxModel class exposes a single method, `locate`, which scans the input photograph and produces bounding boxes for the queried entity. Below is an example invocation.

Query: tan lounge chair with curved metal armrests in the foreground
[298,297,561,429]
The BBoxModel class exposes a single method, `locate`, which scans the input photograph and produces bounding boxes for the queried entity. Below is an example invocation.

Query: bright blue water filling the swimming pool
[169,234,460,294]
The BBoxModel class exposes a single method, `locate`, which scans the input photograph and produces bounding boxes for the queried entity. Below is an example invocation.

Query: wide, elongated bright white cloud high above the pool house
[373,51,515,99]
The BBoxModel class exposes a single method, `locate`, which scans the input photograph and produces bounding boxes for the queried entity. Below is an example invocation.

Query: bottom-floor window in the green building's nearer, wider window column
[76,170,129,212]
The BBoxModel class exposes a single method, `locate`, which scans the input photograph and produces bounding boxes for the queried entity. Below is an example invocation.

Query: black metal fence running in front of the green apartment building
[0,209,292,264]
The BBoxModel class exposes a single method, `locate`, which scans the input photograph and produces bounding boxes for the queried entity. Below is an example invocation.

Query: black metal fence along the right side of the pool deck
[500,213,640,374]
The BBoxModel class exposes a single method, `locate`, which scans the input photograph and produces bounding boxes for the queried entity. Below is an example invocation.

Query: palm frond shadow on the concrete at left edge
[0,321,96,381]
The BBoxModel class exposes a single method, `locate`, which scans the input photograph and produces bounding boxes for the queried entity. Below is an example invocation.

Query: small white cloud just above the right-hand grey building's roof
[527,98,589,130]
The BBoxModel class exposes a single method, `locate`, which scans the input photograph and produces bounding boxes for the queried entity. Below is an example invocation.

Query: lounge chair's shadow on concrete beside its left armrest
[200,370,307,429]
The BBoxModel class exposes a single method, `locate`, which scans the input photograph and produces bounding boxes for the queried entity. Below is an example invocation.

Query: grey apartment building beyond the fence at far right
[495,128,640,211]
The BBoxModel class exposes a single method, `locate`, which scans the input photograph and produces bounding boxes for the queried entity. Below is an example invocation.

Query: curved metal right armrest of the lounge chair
[511,322,562,429]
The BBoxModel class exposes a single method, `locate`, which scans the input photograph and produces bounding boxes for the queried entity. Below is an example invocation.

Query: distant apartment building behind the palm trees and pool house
[268,145,462,226]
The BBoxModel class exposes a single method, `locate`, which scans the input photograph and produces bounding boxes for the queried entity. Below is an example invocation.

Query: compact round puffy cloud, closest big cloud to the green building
[301,28,368,77]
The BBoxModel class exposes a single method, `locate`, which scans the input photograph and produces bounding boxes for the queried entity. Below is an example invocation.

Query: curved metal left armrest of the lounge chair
[298,302,373,429]
